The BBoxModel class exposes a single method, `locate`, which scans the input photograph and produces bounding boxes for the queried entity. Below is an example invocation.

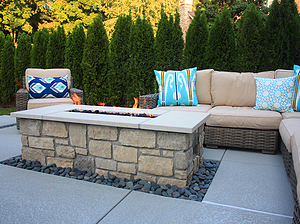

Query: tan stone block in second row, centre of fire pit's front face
[113,145,138,163]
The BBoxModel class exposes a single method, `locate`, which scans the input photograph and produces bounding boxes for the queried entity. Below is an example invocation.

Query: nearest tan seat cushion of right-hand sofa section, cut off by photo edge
[291,129,300,182]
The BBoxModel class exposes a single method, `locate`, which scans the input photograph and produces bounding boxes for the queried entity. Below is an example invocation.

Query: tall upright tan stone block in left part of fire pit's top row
[69,124,86,148]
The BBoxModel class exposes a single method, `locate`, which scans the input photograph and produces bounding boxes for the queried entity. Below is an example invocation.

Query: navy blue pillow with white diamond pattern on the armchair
[27,75,70,98]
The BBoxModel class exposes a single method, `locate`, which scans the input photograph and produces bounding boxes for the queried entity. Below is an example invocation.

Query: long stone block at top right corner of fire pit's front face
[157,132,193,151]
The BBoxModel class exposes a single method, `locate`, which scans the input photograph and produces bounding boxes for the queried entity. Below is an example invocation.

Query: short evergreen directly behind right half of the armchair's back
[46,26,67,68]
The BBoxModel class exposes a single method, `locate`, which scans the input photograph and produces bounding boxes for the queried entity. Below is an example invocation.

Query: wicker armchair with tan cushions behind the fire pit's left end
[16,68,83,129]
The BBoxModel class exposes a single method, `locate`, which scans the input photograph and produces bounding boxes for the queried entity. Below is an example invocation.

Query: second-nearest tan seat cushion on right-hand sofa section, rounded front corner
[279,118,300,152]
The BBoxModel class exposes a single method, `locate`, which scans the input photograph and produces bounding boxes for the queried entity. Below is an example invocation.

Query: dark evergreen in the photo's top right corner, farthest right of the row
[266,0,300,70]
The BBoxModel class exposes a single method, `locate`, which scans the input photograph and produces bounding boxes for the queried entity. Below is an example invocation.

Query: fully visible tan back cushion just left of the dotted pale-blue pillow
[211,71,256,107]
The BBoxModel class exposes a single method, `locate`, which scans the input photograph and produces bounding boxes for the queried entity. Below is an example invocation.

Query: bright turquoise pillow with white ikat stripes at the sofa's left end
[154,67,198,106]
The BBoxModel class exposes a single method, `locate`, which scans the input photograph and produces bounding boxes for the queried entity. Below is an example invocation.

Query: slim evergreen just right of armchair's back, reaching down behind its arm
[65,24,85,89]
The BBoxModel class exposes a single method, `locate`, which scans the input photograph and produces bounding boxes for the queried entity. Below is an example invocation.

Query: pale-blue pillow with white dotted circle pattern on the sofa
[253,76,295,112]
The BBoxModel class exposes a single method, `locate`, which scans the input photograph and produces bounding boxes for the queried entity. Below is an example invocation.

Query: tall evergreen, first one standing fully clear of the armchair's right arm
[81,15,109,104]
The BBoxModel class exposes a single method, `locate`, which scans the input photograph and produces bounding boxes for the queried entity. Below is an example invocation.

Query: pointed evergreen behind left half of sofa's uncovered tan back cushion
[206,9,236,71]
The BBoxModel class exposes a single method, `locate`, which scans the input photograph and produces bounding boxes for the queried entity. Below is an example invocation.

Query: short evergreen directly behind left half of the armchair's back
[30,28,49,68]
